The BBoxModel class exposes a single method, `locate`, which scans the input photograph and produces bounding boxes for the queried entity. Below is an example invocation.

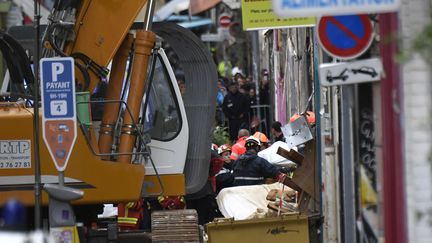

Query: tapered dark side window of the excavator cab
[144,56,181,141]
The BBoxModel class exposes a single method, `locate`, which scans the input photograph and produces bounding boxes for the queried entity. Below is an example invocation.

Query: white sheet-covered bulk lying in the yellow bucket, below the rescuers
[216,182,291,220]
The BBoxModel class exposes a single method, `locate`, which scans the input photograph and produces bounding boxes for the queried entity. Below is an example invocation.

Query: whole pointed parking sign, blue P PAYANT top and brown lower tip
[40,57,77,171]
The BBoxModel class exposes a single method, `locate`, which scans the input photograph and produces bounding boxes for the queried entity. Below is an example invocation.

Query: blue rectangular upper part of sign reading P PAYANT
[40,57,76,120]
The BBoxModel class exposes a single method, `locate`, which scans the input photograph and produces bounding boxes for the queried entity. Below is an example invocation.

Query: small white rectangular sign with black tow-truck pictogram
[319,58,383,86]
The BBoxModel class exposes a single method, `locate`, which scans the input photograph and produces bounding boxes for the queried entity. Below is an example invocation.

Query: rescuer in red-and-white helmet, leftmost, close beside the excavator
[216,144,234,194]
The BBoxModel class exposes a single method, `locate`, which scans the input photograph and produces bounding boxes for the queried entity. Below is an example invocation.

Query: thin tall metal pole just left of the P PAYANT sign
[33,0,41,229]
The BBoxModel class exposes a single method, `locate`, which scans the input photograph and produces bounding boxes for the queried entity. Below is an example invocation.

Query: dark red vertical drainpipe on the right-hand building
[379,13,407,243]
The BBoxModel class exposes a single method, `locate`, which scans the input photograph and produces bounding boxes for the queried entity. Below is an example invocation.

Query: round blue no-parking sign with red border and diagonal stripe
[317,15,373,59]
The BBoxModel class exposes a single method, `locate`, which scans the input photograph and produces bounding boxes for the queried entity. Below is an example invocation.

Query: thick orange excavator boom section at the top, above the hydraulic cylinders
[66,0,147,90]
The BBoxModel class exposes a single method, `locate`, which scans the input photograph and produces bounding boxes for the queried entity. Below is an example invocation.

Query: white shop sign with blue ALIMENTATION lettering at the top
[272,0,401,17]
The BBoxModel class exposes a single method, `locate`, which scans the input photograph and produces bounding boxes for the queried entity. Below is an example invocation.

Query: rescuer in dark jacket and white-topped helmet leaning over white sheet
[233,136,285,186]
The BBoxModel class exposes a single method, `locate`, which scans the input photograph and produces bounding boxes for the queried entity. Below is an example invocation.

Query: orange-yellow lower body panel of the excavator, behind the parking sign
[0,103,144,205]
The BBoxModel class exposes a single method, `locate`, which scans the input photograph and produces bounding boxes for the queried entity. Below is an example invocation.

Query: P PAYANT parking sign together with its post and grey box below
[39,57,84,242]
